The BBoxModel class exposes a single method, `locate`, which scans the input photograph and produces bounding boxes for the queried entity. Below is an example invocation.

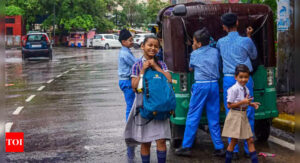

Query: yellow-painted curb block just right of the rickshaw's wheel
[272,113,296,133]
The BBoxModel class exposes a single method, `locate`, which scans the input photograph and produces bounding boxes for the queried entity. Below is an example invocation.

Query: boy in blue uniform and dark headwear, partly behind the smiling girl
[118,29,137,121]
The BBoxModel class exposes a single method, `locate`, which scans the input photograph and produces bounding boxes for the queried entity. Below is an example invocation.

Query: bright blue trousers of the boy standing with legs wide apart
[182,80,224,150]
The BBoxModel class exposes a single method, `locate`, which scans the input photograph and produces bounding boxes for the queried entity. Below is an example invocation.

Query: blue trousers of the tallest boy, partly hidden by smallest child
[223,74,255,153]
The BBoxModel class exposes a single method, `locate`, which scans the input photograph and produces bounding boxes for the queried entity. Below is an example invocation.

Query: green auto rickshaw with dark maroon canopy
[157,2,278,148]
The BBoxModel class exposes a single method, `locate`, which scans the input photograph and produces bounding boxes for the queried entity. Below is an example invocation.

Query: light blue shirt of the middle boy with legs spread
[189,45,221,81]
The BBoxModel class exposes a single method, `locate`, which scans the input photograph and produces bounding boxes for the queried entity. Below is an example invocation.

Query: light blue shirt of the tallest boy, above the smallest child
[217,32,257,74]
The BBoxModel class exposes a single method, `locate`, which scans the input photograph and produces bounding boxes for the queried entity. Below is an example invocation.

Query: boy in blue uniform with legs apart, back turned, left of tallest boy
[175,29,225,156]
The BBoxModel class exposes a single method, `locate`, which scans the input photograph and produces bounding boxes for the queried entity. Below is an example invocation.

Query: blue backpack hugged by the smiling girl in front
[139,68,176,120]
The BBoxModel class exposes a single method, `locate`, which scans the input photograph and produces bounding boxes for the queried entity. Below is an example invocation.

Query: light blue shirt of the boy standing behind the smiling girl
[118,46,137,80]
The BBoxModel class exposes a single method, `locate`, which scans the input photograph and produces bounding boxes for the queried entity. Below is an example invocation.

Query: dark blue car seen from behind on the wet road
[22,32,52,60]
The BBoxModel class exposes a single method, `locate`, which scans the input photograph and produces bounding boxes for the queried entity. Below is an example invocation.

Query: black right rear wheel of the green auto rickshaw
[254,119,272,142]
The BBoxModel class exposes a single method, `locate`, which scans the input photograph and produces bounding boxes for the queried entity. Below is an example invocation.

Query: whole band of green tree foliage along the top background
[6,0,167,33]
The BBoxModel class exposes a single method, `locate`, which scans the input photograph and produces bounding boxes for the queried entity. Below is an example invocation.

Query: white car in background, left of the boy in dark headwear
[92,34,122,49]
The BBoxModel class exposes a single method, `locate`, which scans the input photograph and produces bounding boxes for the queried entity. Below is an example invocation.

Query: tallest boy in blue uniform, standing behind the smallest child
[217,13,257,159]
